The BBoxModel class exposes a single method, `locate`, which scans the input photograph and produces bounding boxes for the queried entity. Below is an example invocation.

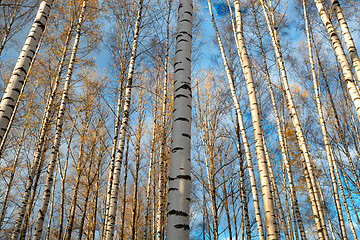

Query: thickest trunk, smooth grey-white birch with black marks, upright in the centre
[166,0,193,237]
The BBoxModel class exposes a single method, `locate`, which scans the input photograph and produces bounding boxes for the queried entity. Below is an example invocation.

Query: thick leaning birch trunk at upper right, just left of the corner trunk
[314,0,360,120]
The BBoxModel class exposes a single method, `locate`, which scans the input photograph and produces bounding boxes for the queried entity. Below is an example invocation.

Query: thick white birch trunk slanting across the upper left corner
[0,0,53,142]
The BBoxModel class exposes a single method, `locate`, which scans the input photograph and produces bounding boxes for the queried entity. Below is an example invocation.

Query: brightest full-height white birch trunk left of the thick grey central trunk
[105,0,143,236]
